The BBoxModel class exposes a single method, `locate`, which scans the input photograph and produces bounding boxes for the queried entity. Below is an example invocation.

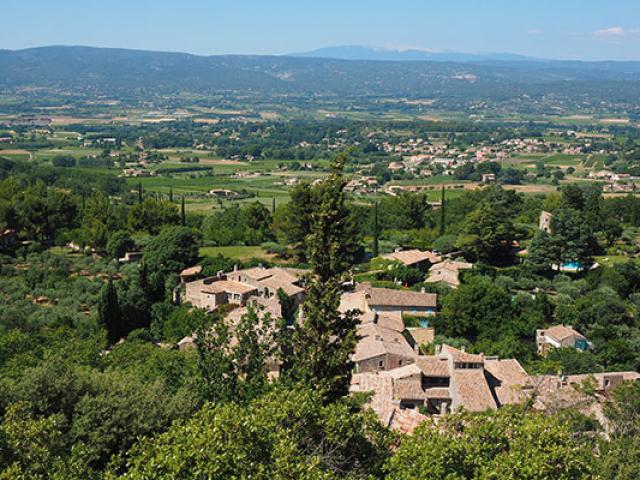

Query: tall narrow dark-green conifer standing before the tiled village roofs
[292,154,358,401]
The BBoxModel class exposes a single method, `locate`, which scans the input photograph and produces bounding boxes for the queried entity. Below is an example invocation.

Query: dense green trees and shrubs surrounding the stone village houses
[0,138,640,480]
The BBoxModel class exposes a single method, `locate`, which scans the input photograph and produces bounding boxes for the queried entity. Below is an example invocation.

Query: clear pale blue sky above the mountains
[0,0,640,60]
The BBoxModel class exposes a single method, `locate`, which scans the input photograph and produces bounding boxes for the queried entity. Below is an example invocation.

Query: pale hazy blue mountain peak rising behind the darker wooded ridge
[288,45,543,62]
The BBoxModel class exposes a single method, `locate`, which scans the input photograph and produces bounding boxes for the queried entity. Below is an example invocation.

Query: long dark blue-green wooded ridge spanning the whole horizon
[0,46,640,104]
